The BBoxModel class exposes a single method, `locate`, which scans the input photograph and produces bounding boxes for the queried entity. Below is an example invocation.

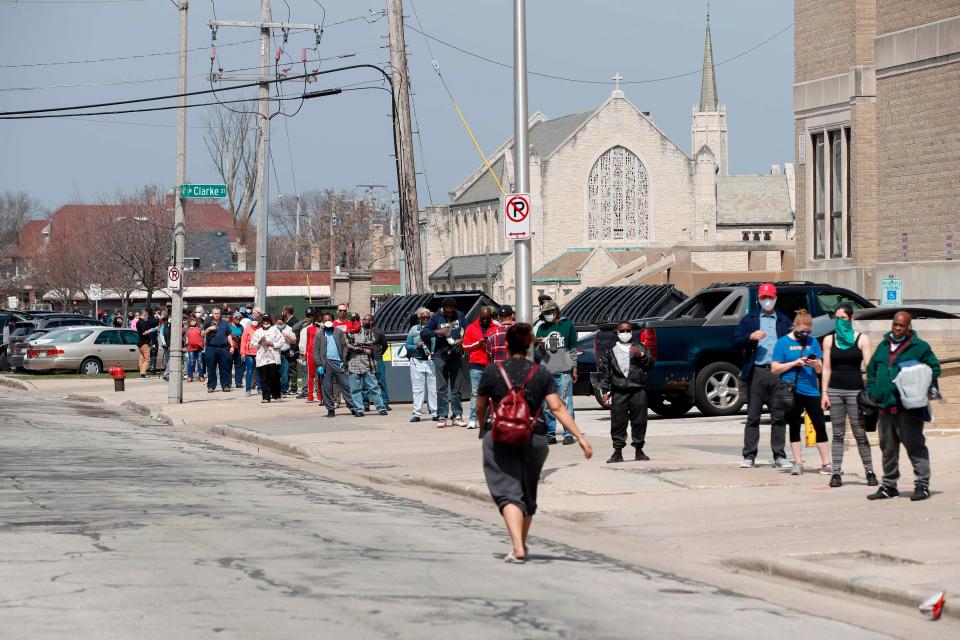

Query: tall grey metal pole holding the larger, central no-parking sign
[513,0,533,322]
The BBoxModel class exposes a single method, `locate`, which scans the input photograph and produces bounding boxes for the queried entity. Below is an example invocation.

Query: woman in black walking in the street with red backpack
[477,323,593,563]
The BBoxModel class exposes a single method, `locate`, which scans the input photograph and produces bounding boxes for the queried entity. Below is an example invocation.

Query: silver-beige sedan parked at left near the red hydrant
[23,325,139,375]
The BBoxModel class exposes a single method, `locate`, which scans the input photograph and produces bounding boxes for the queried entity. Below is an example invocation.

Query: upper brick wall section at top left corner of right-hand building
[794,0,855,82]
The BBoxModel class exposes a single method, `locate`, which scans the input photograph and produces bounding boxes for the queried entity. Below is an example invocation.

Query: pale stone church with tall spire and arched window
[421,17,794,304]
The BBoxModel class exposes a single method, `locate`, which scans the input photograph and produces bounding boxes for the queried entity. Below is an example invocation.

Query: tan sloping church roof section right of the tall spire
[717,175,793,225]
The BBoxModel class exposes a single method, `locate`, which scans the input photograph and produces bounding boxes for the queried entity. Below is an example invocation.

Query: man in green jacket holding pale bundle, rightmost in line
[867,311,940,501]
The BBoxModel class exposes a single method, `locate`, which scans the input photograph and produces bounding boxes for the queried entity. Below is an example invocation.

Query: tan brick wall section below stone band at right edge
[877,63,960,261]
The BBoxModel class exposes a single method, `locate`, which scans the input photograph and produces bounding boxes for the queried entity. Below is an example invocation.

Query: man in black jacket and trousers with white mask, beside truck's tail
[597,322,654,464]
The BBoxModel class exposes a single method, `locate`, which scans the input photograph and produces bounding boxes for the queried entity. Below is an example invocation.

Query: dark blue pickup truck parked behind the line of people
[590,282,874,417]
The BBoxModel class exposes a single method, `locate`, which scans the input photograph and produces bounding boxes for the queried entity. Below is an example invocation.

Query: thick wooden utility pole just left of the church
[387,0,424,293]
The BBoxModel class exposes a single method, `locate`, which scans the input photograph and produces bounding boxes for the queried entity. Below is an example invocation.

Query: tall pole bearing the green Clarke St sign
[167,0,190,404]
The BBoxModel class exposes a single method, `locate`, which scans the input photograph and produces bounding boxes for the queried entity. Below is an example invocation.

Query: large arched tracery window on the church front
[587,146,650,240]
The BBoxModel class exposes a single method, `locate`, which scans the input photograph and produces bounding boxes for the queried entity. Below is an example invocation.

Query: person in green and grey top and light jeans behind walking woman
[534,300,577,444]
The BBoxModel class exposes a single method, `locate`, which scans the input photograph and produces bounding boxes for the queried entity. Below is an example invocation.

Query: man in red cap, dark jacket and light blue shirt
[733,282,793,470]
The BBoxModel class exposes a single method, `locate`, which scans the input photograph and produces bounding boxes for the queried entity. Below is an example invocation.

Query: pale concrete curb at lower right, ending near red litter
[722,557,960,619]
